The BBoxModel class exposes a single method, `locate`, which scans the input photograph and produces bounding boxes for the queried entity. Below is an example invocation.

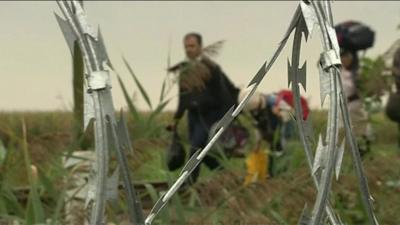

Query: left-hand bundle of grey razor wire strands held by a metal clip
[55,1,144,225]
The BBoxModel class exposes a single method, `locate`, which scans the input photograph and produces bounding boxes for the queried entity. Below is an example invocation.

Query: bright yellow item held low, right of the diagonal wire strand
[244,149,268,185]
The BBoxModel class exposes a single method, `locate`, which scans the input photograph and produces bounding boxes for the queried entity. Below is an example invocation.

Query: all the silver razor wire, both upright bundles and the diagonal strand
[56,0,378,225]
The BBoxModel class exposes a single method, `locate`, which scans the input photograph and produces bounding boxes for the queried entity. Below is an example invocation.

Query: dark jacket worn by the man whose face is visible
[174,57,239,119]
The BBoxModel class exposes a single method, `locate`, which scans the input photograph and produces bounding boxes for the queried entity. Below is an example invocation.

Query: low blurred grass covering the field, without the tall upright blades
[0,111,400,225]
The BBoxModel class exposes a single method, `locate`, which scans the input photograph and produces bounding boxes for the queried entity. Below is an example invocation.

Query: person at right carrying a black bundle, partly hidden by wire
[335,21,375,157]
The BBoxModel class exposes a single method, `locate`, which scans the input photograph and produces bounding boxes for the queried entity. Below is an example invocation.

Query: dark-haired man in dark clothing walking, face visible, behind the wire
[169,33,238,183]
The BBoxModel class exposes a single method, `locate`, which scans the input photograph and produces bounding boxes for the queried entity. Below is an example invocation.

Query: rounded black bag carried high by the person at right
[335,21,375,51]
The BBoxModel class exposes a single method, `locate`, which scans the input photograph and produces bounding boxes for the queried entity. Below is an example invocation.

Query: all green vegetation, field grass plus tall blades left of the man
[0,56,400,225]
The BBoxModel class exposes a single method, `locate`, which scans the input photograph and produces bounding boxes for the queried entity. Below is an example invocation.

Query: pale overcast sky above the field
[0,1,400,111]
